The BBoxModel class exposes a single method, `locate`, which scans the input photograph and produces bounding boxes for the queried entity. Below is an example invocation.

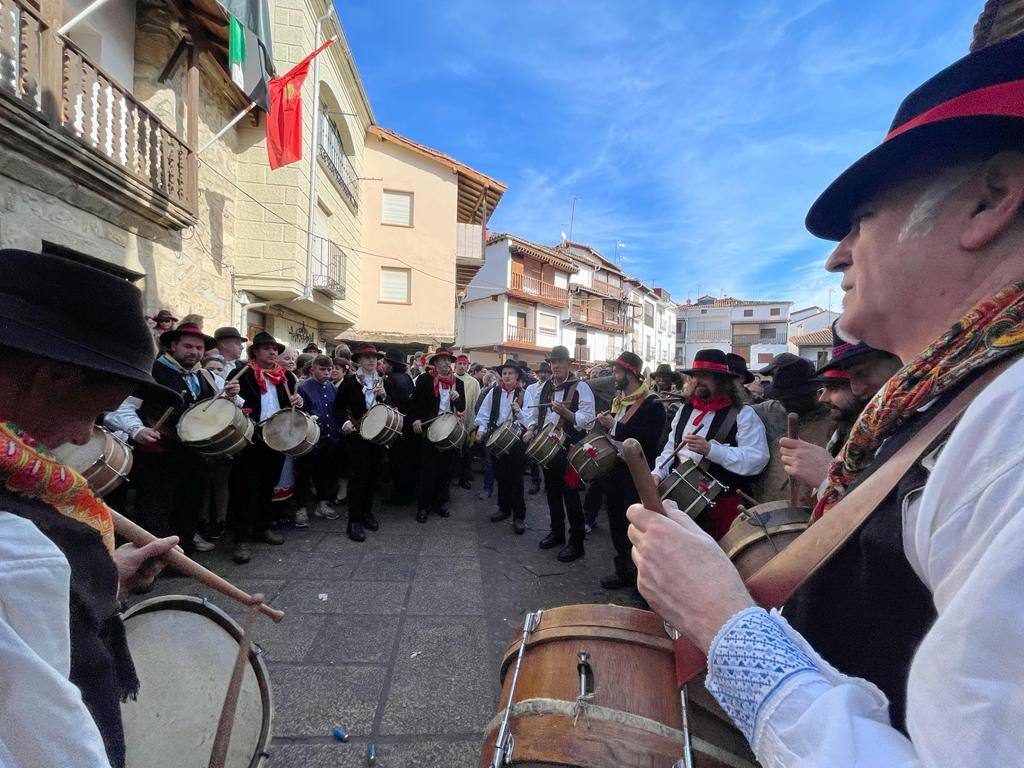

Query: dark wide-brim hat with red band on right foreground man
[805,36,1024,241]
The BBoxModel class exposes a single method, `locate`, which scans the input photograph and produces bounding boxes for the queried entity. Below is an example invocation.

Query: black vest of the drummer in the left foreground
[0,486,138,768]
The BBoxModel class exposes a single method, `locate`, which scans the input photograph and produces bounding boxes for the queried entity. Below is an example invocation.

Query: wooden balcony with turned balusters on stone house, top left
[0,0,198,229]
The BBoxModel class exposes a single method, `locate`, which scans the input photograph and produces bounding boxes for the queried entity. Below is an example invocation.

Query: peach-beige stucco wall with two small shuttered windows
[358,135,459,342]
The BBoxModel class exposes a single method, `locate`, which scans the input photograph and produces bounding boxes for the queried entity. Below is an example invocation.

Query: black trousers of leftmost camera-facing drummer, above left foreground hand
[131,449,208,552]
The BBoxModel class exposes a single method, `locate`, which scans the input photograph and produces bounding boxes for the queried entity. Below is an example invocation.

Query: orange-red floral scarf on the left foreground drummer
[0,421,114,552]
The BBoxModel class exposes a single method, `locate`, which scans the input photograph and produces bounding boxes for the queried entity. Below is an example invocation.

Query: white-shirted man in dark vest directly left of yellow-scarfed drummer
[523,346,596,562]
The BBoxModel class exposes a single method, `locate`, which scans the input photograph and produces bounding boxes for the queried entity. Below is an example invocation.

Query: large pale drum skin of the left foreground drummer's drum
[121,595,273,768]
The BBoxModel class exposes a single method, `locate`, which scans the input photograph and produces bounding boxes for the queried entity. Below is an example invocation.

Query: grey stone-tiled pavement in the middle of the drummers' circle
[140,478,634,768]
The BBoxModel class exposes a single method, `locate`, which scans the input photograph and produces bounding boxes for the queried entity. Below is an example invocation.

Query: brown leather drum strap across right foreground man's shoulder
[676,355,1018,681]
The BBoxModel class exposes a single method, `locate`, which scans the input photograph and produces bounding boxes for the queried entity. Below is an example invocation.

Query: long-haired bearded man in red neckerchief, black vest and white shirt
[651,349,768,539]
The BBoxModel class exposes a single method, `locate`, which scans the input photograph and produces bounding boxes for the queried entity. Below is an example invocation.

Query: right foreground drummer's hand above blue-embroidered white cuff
[627,502,754,653]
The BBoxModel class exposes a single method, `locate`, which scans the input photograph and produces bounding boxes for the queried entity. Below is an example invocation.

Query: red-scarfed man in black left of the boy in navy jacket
[227,331,303,564]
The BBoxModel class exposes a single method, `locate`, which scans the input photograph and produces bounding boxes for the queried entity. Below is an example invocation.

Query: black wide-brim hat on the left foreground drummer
[0,249,180,405]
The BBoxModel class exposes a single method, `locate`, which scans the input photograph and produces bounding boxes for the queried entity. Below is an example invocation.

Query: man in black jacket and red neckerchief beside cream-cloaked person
[413,347,466,522]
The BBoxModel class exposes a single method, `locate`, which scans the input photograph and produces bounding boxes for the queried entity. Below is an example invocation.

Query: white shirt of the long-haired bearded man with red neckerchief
[652,406,771,480]
